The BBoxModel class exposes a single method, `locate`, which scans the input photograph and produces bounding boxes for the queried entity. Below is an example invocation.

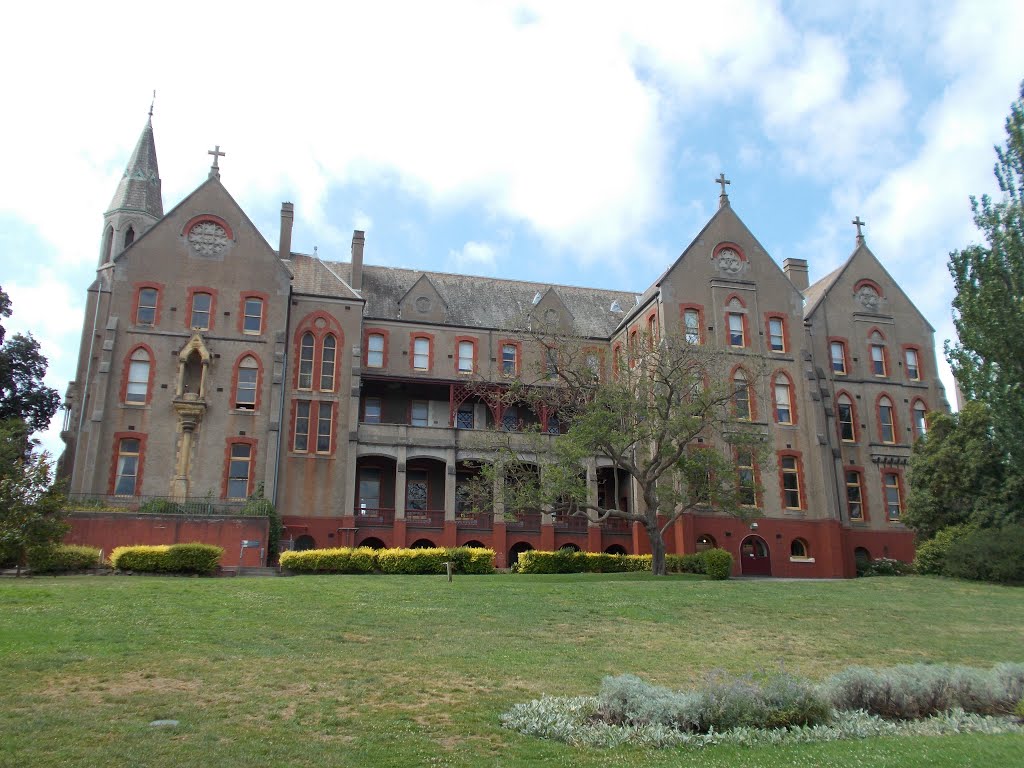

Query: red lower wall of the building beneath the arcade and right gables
[282,515,913,579]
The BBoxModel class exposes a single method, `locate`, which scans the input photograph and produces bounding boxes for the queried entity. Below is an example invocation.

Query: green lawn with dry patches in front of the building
[0,573,1024,768]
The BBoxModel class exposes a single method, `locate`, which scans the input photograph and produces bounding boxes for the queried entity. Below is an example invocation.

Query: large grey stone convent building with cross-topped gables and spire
[62,118,948,577]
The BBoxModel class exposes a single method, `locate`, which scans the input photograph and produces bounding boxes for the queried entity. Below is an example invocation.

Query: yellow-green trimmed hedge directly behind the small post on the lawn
[280,547,495,574]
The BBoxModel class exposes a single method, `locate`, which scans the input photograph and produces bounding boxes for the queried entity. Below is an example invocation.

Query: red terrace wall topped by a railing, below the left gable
[65,512,269,565]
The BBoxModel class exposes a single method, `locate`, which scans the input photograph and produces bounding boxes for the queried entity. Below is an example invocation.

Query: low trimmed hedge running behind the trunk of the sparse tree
[513,549,732,579]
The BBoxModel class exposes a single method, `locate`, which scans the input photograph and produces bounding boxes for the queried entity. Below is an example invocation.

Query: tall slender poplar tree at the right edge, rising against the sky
[946,83,1024,466]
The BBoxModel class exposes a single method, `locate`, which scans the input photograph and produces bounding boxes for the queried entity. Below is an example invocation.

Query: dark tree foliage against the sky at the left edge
[0,289,60,432]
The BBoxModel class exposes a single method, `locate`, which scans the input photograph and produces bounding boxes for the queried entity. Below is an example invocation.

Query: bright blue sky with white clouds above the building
[0,0,1024,460]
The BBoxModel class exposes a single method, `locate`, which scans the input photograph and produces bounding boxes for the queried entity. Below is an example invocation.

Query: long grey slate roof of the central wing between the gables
[311,264,637,338]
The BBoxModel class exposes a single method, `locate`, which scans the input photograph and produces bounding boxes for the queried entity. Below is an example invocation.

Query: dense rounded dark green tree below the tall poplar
[903,401,1019,540]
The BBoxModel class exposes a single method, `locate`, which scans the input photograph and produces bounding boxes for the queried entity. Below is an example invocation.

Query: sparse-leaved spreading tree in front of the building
[468,336,767,575]
